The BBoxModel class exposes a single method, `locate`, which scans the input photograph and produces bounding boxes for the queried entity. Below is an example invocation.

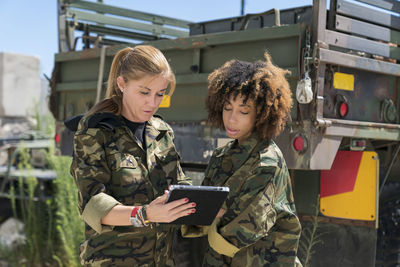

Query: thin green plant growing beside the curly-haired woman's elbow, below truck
[299,195,325,267]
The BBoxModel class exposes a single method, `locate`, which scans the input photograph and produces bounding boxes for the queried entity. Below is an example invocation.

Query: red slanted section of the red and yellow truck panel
[320,151,362,197]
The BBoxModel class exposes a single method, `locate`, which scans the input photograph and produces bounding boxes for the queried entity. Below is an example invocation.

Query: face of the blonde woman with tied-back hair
[117,75,169,122]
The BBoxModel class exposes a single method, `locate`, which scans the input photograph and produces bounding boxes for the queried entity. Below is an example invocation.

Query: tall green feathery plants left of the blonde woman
[0,148,84,267]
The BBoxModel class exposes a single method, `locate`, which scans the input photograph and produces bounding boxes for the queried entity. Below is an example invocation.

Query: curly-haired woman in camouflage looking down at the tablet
[182,53,301,266]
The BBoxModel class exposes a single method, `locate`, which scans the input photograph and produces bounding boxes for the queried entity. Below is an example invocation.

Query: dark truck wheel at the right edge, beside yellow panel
[376,182,400,267]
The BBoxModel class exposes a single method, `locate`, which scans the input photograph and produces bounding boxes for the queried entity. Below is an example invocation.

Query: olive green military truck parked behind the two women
[50,0,400,266]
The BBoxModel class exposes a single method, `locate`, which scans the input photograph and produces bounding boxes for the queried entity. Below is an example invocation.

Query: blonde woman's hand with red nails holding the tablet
[146,191,196,223]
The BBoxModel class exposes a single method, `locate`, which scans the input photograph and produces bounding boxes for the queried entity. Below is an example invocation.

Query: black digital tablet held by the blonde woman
[167,185,229,225]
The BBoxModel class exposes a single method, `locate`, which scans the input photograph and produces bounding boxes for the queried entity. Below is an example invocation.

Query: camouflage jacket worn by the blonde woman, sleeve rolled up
[71,113,190,266]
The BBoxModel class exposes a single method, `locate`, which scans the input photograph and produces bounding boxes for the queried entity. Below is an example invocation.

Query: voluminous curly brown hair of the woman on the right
[206,52,292,139]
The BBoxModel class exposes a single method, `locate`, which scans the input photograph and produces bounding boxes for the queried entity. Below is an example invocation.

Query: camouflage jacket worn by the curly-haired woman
[203,135,301,267]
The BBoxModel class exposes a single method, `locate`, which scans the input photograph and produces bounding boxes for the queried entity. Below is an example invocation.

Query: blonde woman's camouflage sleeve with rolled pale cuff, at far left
[71,129,120,233]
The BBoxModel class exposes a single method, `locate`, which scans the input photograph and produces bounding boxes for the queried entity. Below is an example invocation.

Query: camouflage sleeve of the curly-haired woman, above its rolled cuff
[218,166,277,248]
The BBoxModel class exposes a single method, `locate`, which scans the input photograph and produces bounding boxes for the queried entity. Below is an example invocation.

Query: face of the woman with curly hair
[222,95,256,144]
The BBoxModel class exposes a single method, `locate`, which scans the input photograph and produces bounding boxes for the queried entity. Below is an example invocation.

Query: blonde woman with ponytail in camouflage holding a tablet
[71,45,195,266]
